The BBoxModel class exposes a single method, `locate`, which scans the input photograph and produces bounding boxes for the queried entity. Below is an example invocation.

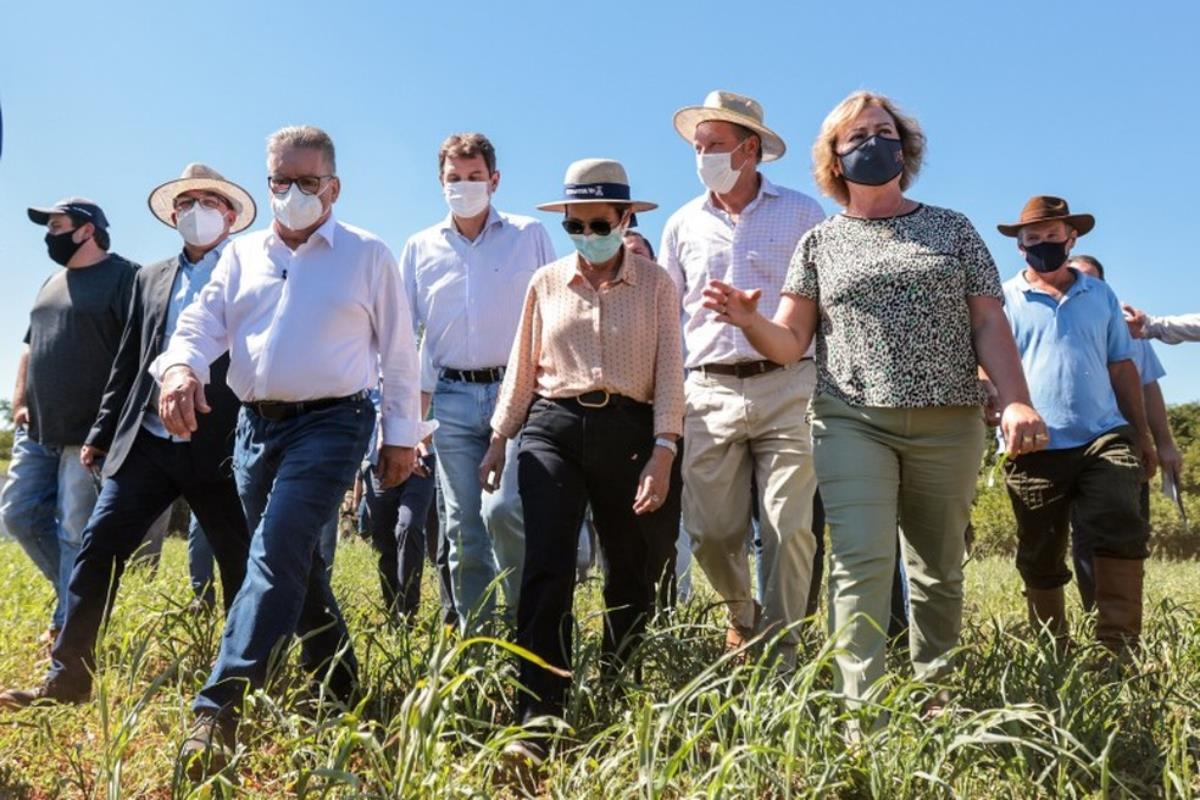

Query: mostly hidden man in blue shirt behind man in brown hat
[1067,255,1183,612]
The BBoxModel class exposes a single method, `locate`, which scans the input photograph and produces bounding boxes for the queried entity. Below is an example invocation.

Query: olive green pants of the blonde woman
[812,396,984,699]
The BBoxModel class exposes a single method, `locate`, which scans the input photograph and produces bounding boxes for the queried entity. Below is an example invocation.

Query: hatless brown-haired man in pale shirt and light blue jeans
[400,133,554,626]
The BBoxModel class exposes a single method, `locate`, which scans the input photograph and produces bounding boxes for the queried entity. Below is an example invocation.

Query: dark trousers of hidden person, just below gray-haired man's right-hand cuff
[362,455,449,616]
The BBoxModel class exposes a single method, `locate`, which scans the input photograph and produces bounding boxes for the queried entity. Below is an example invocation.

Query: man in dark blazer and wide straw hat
[0,164,254,708]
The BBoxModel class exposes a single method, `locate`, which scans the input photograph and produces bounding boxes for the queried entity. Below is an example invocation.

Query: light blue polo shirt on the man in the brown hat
[1004,270,1134,450]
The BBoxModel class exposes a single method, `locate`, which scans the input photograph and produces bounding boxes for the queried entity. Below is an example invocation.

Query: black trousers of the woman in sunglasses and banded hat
[517,398,678,721]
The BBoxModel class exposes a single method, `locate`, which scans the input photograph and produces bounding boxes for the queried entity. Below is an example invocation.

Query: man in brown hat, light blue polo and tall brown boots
[998,197,1157,651]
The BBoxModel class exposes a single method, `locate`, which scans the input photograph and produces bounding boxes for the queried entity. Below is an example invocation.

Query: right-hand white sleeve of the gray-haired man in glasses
[372,245,437,447]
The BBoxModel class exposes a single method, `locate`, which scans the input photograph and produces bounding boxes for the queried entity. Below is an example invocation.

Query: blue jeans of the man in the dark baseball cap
[0,428,98,628]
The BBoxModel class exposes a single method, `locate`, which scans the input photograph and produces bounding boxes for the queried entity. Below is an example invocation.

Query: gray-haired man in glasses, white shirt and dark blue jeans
[151,126,427,778]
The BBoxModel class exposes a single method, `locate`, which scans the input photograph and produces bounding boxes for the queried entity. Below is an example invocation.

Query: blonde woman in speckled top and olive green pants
[706,91,1046,699]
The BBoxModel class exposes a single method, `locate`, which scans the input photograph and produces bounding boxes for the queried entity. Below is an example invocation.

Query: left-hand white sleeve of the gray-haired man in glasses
[150,247,240,384]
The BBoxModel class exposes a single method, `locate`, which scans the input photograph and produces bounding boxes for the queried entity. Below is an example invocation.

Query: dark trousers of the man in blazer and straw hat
[50,431,250,692]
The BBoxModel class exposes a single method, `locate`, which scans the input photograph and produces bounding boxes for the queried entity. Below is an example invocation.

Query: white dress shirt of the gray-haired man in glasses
[150,215,432,446]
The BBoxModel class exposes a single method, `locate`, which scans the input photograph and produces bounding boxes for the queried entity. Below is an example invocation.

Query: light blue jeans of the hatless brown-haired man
[433,378,524,621]
